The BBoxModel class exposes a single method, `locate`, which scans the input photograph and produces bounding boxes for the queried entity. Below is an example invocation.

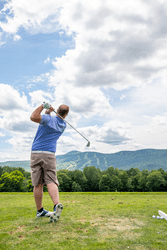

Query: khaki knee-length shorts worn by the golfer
[30,153,59,187]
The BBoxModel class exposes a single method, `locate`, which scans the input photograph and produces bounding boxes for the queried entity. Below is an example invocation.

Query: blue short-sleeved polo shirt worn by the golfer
[32,114,66,153]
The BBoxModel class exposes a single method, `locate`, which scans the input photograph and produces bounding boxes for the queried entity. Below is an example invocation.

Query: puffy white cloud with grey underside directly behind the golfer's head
[51,84,112,118]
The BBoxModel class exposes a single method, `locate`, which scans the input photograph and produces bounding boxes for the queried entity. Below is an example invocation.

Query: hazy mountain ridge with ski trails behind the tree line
[0,149,167,171]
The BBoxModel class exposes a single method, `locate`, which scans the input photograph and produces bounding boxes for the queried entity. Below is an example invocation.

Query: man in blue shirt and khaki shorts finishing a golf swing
[30,103,69,221]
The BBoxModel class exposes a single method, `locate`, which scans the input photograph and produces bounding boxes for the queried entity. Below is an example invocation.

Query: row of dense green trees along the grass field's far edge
[0,166,167,192]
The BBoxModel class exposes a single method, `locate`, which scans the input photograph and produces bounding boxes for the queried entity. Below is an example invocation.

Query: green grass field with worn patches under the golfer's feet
[0,193,167,250]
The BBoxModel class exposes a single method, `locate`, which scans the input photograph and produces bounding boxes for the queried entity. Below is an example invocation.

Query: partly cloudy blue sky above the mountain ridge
[0,0,167,162]
